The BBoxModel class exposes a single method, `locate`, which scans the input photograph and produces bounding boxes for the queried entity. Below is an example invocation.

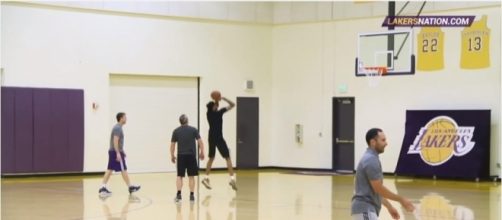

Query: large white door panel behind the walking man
[109,74,198,172]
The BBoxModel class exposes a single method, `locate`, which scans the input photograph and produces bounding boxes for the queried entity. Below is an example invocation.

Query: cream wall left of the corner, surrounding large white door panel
[1,2,271,172]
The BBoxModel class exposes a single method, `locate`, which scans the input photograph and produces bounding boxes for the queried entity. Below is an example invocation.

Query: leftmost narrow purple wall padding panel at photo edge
[1,88,16,173]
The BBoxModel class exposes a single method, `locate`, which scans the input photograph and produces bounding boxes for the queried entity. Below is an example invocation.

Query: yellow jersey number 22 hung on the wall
[417,27,444,71]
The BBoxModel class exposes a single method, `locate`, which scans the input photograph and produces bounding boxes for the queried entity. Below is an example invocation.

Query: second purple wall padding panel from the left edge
[14,88,33,173]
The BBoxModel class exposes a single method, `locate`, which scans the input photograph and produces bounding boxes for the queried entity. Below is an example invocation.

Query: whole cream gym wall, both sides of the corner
[1,2,501,178]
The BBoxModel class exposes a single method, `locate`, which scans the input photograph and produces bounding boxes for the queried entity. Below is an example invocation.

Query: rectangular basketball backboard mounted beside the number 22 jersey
[355,29,415,76]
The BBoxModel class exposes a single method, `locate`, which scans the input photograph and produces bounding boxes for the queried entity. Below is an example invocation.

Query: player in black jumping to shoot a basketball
[202,97,237,190]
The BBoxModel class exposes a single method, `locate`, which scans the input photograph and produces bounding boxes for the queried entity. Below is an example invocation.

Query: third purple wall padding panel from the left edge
[33,89,53,172]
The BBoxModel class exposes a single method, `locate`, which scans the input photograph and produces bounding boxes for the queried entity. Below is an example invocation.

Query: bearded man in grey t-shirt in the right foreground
[351,128,415,220]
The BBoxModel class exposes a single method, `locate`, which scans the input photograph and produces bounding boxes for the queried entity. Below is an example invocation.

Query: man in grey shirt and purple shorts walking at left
[99,112,141,196]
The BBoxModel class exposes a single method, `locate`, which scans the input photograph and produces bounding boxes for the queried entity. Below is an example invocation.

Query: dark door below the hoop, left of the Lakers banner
[333,97,355,173]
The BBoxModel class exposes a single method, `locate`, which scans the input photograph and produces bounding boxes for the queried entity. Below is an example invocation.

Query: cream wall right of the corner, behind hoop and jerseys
[272,5,501,175]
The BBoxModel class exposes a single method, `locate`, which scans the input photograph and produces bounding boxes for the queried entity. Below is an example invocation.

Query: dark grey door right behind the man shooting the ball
[237,97,260,168]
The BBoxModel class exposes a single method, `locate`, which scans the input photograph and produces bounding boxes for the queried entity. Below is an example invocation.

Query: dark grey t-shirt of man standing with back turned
[171,125,200,155]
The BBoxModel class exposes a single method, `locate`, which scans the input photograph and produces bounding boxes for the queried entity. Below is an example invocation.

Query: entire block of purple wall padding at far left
[2,87,84,173]
